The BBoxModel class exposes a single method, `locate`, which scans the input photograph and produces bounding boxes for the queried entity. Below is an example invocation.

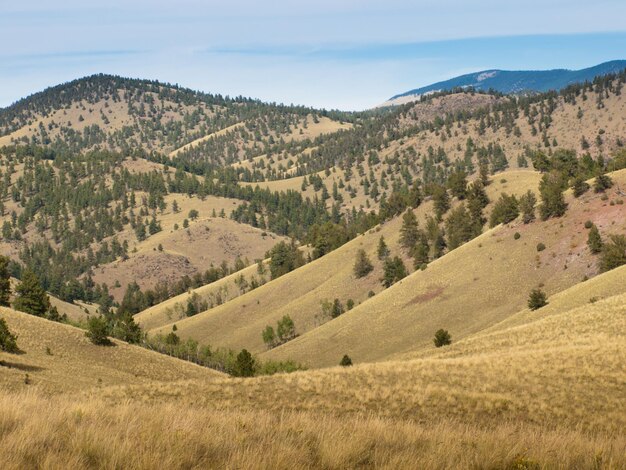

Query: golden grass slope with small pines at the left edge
[0,308,221,393]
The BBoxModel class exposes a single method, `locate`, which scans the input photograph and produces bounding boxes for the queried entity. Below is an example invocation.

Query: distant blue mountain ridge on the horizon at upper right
[385,60,626,105]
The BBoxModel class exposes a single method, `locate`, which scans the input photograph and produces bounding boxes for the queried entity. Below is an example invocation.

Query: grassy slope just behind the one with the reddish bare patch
[149,171,539,352]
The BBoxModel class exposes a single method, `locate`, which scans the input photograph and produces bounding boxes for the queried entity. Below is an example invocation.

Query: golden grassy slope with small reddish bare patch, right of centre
[267,171,626,366]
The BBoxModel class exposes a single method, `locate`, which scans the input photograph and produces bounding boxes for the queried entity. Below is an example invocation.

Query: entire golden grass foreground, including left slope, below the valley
[0,280,626,469]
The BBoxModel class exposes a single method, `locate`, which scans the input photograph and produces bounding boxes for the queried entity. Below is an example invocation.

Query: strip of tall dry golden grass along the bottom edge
[0,394,626,470]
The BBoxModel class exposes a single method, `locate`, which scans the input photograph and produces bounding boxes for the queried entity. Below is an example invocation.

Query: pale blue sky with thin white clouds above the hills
[0,0,626,110]
